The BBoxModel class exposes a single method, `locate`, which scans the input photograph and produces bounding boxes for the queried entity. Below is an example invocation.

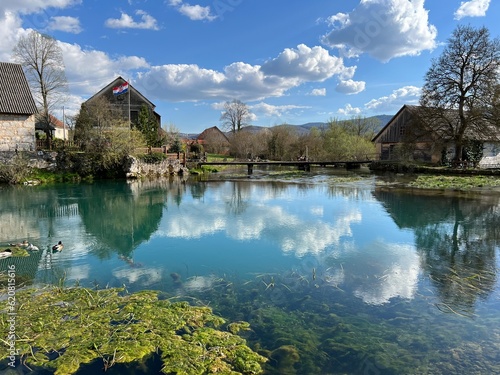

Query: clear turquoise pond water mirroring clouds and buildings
[0,174,500,374]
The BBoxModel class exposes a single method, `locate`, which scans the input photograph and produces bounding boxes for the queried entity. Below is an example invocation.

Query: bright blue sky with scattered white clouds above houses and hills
[0,0,500,133]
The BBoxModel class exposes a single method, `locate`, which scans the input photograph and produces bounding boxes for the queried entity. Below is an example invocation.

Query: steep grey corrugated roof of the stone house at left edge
[0,62,37,115]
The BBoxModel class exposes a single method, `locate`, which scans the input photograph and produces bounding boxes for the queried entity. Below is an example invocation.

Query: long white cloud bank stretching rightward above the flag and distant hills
[137,44,354,101]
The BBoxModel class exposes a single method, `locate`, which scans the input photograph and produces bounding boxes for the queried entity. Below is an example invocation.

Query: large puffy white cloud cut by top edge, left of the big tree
[323,0,437,62]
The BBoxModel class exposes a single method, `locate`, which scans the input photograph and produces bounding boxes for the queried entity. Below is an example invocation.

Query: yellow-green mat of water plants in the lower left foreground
[0,288,266,375]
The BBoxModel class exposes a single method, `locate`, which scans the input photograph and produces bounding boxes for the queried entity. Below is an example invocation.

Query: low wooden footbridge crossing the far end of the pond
[198,159,373,175]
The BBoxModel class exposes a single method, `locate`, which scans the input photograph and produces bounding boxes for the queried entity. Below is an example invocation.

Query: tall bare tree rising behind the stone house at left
[13,30,67,144]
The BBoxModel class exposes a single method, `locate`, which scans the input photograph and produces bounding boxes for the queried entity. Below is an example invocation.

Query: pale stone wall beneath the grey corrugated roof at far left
[0,114,35,152]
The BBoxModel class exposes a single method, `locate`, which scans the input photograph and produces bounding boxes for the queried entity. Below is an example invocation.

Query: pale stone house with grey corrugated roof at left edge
[0,62,38,152]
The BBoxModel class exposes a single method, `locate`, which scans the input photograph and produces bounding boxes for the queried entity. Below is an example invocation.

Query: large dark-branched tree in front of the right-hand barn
[420,25,500,160]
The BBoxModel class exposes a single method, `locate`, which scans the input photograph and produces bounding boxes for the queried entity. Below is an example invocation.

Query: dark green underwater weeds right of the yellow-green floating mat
[172,268,500,375]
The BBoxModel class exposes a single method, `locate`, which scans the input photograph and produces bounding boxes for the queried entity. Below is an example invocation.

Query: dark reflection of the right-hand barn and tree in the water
[374,189,500,315]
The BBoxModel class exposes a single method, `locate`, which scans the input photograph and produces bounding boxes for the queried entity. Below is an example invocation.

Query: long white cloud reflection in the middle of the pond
[156,197,362,257]
